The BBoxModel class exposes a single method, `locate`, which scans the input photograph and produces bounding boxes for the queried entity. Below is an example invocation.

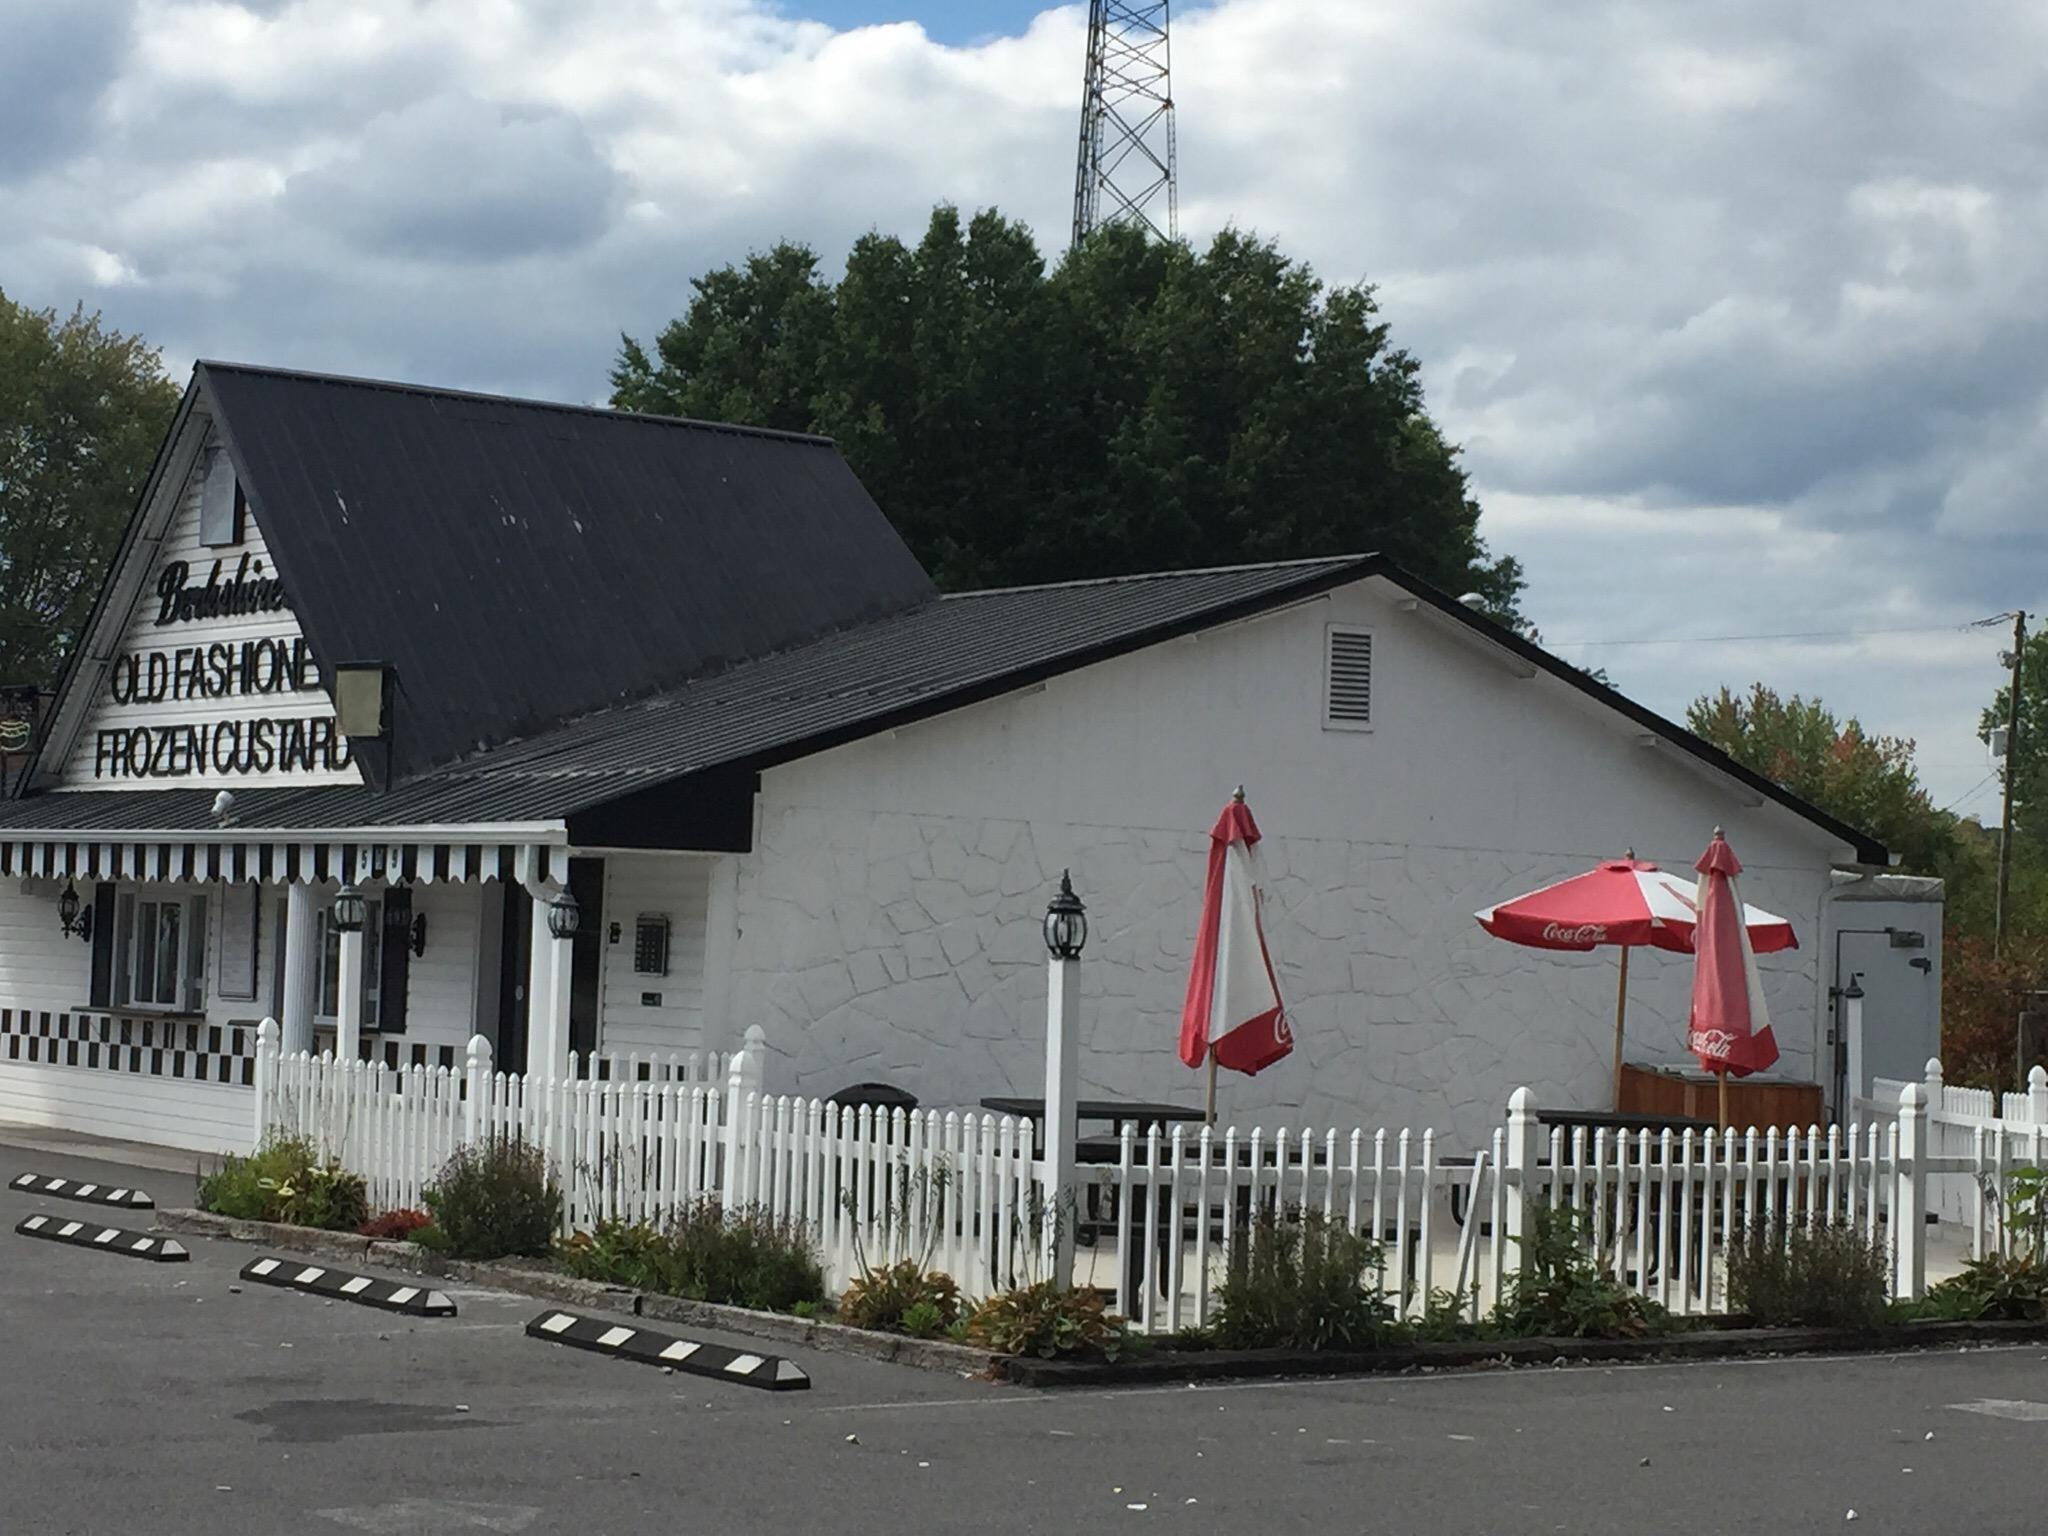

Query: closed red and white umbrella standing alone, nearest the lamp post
[1180,788,1294,1120]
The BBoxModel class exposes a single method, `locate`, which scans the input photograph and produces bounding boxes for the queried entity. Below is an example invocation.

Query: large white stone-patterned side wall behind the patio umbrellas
[733,584,1849,1145]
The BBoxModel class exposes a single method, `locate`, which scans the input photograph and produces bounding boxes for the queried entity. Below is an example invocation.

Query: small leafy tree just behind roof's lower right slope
[1686,682,1956,874]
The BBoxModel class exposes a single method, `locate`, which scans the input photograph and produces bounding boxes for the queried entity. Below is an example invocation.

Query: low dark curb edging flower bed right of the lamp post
[1004,1321,2048,1386]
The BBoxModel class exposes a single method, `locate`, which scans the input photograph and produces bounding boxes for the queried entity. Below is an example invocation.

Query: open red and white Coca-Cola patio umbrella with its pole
[1475,848,1798,1108]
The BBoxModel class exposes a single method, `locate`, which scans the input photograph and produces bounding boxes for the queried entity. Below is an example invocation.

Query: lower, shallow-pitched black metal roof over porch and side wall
[0,555,1888,866]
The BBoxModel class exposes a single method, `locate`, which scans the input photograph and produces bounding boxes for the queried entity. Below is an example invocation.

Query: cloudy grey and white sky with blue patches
[0,0,2048,831]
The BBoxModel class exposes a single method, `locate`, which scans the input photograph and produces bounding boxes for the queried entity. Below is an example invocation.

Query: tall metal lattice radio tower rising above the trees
[1073,0,1180,246]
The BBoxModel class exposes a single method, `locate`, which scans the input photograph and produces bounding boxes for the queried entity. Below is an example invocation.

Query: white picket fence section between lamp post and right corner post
[1087,1096,1913,1333]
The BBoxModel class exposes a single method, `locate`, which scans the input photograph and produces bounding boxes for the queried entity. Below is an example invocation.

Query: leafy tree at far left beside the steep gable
[0,293,178,684]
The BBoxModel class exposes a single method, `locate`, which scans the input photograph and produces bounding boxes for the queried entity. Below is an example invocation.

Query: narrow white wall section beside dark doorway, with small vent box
[598,854,717,1055]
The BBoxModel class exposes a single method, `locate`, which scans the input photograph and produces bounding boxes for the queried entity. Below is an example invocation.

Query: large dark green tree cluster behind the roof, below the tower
[612,207,1524,616]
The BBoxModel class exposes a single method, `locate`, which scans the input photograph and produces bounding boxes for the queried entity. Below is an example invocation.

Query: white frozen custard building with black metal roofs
[0,365,1939,1147]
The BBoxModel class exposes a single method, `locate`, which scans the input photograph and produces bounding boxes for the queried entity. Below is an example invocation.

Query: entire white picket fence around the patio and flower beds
[256,1024,2048,1333]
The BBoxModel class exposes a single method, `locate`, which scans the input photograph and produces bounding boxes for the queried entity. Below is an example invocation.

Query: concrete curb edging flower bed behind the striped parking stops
[156,1208,1006,1376]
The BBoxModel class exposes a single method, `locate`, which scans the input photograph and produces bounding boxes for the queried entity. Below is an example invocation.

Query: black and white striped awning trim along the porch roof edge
[0,840,569,885]
